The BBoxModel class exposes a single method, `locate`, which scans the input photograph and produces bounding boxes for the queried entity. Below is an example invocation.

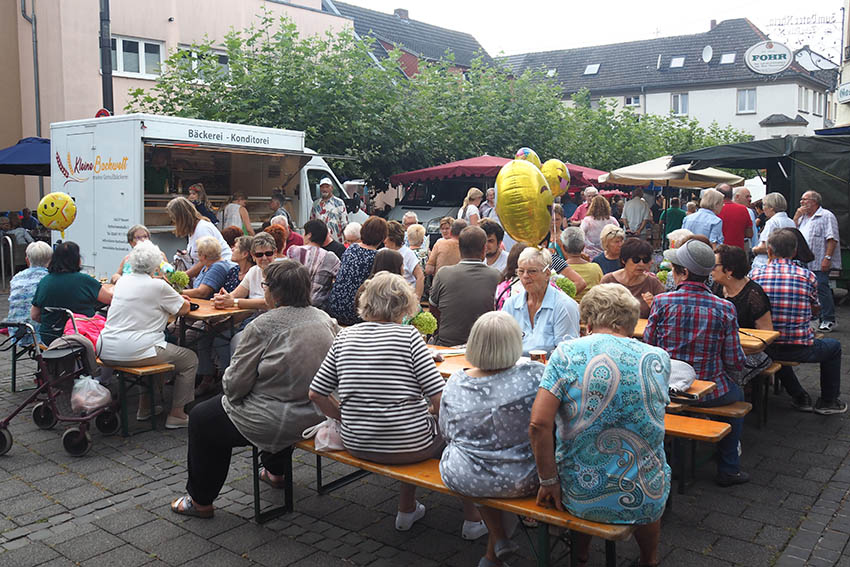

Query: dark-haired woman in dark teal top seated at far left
[31,242,112,346]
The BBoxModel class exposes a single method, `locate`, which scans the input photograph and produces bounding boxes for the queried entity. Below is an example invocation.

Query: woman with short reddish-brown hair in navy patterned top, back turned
[324,216,387,325]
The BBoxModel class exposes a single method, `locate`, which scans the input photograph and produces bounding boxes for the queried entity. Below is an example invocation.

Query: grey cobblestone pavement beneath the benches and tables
[0,296,850,567]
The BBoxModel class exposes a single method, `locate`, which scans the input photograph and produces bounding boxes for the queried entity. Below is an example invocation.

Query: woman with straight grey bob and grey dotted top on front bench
[440,311,544,567]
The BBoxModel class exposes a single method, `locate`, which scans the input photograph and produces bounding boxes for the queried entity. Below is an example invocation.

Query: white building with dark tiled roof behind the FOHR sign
[498,19,837,139]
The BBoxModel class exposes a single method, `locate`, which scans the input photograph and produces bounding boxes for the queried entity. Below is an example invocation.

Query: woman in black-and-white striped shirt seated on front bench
[310,272,445,531]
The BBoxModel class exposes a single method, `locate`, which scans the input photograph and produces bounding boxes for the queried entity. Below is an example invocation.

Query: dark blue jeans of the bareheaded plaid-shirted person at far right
[766,339,841,402]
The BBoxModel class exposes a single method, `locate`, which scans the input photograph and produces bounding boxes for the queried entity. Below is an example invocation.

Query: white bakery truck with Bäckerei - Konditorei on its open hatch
[50,114,358,278]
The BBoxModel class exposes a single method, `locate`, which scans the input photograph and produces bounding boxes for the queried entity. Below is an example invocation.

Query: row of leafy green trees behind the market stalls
[126,12,746,186]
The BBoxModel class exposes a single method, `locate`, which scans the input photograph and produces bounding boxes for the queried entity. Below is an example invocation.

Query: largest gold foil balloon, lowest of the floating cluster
[496,160,555,246]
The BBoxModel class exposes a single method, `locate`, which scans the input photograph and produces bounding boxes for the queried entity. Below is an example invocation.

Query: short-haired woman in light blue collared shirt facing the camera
[502,246,579,352]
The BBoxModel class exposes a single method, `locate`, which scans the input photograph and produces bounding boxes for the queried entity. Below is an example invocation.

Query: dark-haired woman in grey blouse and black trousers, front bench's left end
[171,259,337,518]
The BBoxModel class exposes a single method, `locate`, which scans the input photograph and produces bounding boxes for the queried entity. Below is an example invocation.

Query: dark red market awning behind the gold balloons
[390,155,606,193]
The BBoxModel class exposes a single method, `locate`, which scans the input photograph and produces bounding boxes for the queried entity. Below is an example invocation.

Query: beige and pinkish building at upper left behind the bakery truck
[0,0,352,210]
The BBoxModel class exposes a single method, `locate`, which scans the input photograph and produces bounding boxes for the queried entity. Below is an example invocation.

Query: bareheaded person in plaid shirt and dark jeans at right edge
[750,229,847,415]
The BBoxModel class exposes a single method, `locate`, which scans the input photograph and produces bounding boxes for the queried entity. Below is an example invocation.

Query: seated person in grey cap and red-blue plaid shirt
[643,240,750,486]
